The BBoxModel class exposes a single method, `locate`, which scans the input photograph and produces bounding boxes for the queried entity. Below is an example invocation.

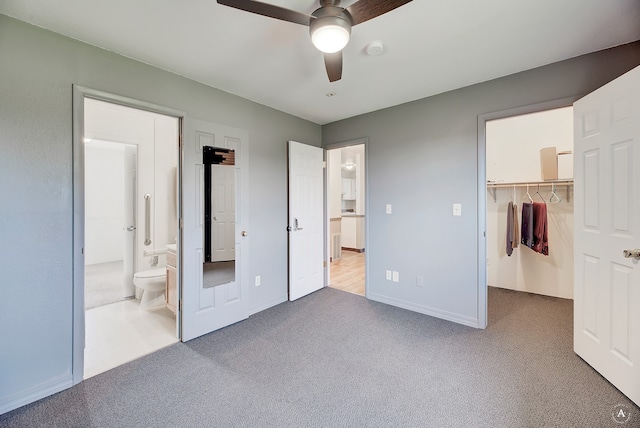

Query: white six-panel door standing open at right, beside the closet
[574,68,640,404]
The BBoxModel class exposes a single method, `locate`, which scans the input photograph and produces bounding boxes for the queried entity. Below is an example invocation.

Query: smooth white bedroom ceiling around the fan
[0,0,640,124]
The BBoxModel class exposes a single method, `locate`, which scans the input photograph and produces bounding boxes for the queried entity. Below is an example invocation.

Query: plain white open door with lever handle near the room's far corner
[288,141,324,300]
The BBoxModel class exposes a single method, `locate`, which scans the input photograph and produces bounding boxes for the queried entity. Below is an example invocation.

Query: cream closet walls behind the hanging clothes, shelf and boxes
[486,107,574,299]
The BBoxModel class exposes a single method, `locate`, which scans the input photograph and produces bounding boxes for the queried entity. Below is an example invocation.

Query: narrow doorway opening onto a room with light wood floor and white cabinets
[326,140,366,296]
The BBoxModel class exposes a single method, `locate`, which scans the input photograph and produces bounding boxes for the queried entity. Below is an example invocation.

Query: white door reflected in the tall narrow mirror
[211,165,236,262]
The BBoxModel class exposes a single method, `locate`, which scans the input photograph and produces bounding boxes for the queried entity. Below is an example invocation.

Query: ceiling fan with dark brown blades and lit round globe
[217,0,412,82]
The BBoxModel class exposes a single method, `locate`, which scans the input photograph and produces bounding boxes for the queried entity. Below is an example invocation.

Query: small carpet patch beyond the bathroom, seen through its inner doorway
[84,260,131,309]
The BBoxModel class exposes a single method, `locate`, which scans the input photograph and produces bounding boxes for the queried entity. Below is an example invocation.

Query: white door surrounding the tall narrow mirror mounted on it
[181,118,249,342]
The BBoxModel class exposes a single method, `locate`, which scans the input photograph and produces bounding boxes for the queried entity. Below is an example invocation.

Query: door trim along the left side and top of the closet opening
[476,95,582,329]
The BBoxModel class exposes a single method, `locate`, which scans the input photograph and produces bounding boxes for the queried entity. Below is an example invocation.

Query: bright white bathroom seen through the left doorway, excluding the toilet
[83,98,179,379]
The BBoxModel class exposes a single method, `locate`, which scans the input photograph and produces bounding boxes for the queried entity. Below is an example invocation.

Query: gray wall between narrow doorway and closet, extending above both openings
[322,42,640,325]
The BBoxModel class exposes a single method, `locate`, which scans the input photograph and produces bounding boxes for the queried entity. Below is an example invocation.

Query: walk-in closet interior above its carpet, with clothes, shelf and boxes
[486,107,574,299]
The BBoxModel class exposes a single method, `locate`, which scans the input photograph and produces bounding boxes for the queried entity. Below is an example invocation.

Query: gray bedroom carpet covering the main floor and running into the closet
[0,288,640,428]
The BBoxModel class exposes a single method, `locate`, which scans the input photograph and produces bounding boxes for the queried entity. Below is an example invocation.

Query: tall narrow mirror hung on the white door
[202,146,236,288]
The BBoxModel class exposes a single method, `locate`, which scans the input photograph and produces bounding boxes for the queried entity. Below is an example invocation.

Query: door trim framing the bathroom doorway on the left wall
[71,85,186,385]
